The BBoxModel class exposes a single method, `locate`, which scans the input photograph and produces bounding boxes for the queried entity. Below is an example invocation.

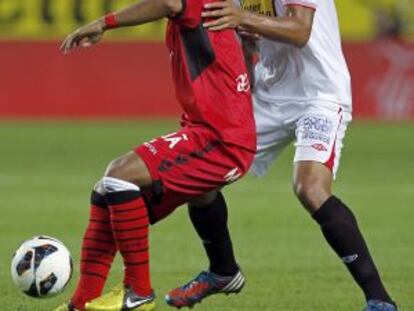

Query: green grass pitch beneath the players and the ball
[0,120,414,311]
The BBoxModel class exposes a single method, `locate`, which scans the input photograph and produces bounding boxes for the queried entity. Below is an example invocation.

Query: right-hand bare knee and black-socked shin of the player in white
[295,161,395,311]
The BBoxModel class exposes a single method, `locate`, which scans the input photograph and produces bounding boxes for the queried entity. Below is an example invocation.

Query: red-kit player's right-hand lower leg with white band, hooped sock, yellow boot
[78,176,155,311]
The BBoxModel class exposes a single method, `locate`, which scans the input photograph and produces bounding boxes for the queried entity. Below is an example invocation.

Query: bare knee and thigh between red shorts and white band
[105,151,152,186]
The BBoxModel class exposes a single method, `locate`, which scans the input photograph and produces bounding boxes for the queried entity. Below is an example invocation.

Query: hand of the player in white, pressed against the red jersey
[201,0,244,31]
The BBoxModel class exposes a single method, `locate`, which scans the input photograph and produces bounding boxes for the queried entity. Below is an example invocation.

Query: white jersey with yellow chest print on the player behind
[242,0,352,112]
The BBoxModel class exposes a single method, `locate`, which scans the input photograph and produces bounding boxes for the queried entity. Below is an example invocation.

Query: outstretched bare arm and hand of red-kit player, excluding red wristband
[60,0,182,53]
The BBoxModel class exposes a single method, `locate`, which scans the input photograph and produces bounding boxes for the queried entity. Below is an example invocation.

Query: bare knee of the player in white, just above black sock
[293,179,330,213]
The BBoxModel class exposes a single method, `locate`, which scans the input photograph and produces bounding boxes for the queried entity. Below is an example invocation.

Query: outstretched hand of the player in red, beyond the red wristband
[60,20,105,54]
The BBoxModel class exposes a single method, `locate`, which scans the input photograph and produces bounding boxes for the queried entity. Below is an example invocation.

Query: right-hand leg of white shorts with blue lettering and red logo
[294,104,351,177]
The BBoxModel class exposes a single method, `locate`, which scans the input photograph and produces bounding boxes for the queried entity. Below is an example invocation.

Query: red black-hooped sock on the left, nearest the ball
[72,192,116,310]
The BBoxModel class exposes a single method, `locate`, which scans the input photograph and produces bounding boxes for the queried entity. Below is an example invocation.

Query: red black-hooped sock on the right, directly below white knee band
[105,191,152,296]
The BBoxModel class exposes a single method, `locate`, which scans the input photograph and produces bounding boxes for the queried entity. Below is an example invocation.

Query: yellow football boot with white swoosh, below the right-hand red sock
[85,285,155,311]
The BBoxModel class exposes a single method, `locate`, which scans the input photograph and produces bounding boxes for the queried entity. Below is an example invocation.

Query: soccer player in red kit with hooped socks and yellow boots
[56,0,256,311]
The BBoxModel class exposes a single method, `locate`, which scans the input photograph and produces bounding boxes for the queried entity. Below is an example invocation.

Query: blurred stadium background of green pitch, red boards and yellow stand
[0,0,414,311]
